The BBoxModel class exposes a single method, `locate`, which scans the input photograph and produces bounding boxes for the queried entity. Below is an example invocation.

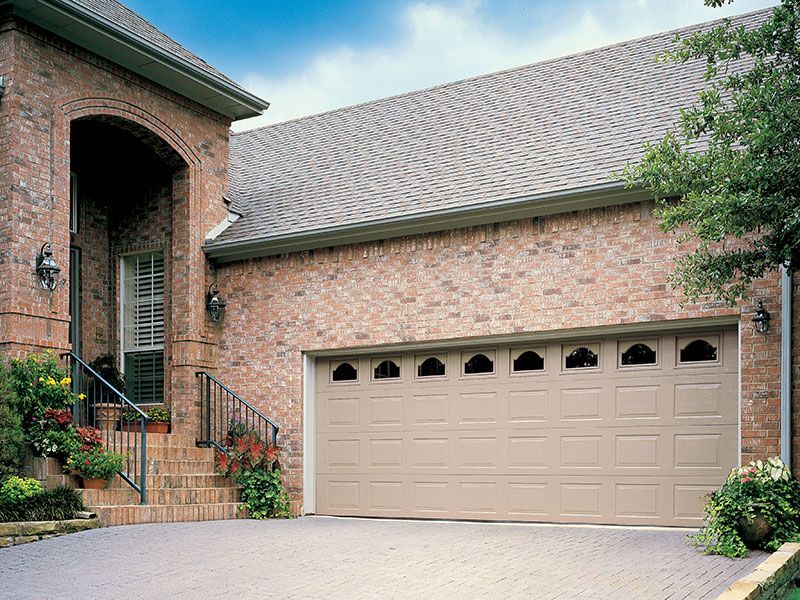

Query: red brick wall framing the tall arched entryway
[0,16,230,428]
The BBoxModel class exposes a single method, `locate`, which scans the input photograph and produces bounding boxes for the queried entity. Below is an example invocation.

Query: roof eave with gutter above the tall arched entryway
[0,0,269,121]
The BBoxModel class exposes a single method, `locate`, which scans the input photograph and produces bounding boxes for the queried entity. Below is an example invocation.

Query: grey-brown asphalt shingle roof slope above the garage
[212,9,771,245]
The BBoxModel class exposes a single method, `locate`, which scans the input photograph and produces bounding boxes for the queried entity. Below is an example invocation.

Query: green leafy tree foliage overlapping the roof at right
[623,0,800,304]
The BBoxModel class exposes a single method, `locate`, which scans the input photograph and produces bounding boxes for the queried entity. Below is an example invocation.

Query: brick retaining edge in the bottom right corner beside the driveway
[718,543,800,600]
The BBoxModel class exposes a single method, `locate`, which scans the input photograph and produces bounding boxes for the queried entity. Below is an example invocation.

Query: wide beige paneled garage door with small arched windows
[315,330,738,525]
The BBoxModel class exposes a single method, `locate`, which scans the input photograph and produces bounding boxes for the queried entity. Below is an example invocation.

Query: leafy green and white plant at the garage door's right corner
[691,456,800,557]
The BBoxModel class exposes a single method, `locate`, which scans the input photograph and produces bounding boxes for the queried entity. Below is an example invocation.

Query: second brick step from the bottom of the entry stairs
[80,487,241,508]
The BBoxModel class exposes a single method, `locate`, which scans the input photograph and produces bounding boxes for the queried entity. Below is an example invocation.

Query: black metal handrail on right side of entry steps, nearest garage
[195,371,280,452]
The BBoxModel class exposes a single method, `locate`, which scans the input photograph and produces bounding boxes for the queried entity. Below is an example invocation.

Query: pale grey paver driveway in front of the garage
[0,517,764,600]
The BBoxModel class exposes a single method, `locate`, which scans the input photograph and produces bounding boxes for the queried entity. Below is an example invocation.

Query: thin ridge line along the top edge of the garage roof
[231,6,775,138]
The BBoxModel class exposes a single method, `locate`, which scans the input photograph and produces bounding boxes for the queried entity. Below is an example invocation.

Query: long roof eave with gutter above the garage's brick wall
[203,181,652,263]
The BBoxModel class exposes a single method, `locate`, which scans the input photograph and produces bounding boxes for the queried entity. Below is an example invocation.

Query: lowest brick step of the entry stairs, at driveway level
[94,502,247,527]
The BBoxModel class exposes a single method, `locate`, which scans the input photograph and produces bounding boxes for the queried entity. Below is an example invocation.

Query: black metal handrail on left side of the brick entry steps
[61,352,148,504]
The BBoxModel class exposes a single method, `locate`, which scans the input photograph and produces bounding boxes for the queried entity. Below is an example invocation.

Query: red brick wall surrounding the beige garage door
[211,203,780,510]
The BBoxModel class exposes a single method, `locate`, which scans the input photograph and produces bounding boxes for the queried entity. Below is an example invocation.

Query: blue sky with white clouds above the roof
[123,0,775,129]
